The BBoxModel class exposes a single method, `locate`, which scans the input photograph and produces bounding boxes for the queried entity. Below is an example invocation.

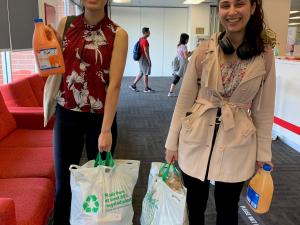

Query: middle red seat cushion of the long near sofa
[0,147,55,182]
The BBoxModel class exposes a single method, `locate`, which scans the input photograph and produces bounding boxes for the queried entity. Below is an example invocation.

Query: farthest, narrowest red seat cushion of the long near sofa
[0,129,53,148]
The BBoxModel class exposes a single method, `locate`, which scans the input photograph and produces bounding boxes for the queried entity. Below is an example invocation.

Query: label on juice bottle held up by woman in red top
[37,48,61,70]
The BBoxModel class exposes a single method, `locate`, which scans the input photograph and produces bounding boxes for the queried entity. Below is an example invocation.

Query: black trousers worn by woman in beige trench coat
[182,109,244,225]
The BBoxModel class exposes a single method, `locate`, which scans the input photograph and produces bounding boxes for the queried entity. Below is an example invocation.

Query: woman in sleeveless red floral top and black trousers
[47,0,128,225]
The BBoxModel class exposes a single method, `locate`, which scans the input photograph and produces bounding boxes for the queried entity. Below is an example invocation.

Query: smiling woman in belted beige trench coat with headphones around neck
[165,0,275,225]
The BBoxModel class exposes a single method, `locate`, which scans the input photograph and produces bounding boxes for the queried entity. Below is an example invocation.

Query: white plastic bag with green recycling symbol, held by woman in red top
[70,153,140,225]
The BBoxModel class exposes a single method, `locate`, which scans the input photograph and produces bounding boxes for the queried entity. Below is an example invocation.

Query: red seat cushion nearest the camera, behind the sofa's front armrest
[0,178,54,225]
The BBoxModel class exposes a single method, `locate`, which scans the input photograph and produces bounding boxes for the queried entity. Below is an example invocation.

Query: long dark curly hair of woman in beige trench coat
[218,0,276,56]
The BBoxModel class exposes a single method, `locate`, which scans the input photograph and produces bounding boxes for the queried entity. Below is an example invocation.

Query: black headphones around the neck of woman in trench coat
[219,32,255,59]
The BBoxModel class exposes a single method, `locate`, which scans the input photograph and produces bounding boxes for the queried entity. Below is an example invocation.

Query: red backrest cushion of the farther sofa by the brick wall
[0,78,39,107]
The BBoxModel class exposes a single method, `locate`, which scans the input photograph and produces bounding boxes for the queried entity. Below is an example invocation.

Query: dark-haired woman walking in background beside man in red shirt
[168,33,192,97]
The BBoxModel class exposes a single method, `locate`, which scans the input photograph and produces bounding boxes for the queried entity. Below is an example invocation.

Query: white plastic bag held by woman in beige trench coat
[140,162,188,225]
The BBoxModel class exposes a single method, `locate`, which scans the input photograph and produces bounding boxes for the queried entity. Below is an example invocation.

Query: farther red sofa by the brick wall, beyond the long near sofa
[0,74,54,129]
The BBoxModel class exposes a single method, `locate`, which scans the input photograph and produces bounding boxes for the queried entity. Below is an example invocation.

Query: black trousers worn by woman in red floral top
[54,105,117,225]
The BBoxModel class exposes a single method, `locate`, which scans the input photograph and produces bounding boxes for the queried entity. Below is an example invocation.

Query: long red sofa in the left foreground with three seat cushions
[0,88,55,225]
